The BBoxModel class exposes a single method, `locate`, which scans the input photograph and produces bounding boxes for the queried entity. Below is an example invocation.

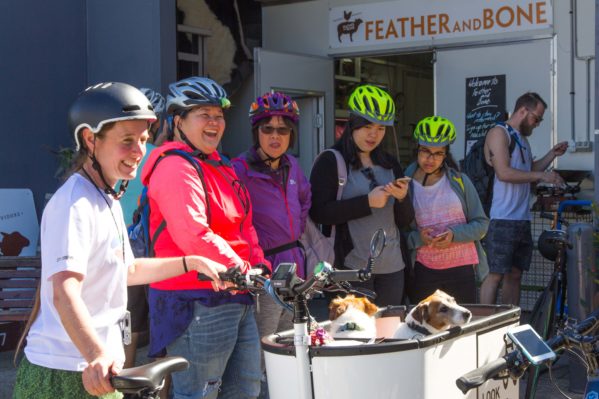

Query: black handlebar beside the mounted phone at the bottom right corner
[456,309,599,394]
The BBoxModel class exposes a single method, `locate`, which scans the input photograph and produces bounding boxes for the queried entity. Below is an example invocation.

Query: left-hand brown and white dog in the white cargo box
[329,295,379,339]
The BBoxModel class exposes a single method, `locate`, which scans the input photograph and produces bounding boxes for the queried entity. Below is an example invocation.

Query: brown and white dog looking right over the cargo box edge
[393,290,472,339]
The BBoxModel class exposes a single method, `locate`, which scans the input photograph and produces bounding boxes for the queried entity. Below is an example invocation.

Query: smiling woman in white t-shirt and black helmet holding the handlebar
[13,83,226,398]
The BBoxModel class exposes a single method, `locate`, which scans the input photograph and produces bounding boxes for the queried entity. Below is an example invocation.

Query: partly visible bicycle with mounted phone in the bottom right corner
[456,309,599,399]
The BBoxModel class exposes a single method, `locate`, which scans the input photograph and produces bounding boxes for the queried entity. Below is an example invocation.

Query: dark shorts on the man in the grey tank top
[483,219,533,274]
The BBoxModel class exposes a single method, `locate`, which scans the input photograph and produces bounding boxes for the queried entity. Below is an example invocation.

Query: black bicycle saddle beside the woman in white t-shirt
[110,356,189,393]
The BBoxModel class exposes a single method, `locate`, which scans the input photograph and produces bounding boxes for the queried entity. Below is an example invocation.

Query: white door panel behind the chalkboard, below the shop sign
[435,39,557,160]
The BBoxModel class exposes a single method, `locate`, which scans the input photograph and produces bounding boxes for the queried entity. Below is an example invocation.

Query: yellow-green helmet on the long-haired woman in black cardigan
[348,85,395,126]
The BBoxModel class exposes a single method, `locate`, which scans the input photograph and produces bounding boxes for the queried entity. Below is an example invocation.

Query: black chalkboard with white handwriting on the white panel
[465,75,506,154]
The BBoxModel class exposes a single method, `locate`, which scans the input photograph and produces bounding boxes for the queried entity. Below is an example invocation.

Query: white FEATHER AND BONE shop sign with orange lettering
[329,0,553,49]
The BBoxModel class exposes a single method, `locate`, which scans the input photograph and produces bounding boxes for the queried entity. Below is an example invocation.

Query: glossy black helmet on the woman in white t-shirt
[69,82,156,150]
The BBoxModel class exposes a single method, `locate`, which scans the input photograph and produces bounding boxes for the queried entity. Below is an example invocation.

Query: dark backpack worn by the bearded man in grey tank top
[462,123,518,216]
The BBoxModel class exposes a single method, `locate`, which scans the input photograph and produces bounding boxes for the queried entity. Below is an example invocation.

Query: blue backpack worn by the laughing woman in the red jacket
[127,150,210,258]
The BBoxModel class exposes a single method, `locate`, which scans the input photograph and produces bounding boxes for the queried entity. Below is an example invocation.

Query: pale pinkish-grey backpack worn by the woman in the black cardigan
[299,148,347,276]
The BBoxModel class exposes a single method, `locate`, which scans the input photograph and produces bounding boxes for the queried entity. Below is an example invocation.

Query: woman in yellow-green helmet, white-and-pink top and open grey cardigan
[406,116,489,303]
